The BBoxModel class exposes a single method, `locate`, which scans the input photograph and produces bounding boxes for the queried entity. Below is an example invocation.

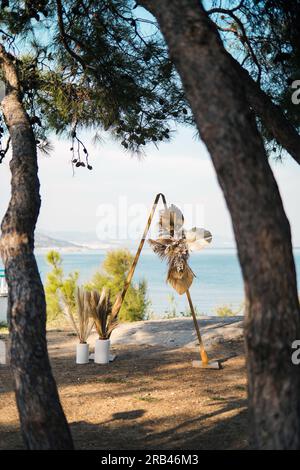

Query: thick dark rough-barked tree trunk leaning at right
[139,0,300,449]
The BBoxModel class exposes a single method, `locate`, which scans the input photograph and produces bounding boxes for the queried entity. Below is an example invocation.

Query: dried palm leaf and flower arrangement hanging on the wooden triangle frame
[148,204,212,295]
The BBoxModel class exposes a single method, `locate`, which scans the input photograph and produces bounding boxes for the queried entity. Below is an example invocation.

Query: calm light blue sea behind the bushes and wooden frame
[0,248,300,320]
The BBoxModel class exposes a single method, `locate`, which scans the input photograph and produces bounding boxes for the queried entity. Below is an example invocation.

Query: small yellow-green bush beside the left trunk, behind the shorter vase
[45,250,79,321]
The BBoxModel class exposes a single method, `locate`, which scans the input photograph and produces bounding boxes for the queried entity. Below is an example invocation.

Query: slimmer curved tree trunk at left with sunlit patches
[0,45,73,449]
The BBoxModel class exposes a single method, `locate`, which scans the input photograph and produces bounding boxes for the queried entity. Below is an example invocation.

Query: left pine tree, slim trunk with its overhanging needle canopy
[0,0,188,449]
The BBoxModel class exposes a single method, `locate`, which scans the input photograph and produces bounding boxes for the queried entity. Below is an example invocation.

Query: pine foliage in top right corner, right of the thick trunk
[205,0,300,159]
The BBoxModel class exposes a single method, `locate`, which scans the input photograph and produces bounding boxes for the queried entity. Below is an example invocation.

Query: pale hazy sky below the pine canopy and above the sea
[0,127,300,246]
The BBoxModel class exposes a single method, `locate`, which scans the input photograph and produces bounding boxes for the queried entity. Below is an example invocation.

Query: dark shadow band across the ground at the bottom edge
[71,405,249,450]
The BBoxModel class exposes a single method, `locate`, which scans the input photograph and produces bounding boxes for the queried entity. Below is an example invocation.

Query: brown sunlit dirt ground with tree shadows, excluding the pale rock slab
[0,332,248,450]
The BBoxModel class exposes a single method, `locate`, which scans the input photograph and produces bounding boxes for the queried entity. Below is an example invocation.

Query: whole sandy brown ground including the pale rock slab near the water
[0,317,248,450]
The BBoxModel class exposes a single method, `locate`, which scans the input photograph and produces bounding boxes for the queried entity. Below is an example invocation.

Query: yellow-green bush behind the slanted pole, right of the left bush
[86,249,150,321]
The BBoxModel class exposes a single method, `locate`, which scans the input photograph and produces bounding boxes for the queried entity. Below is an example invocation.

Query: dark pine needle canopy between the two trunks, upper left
[0,0,193,159]
